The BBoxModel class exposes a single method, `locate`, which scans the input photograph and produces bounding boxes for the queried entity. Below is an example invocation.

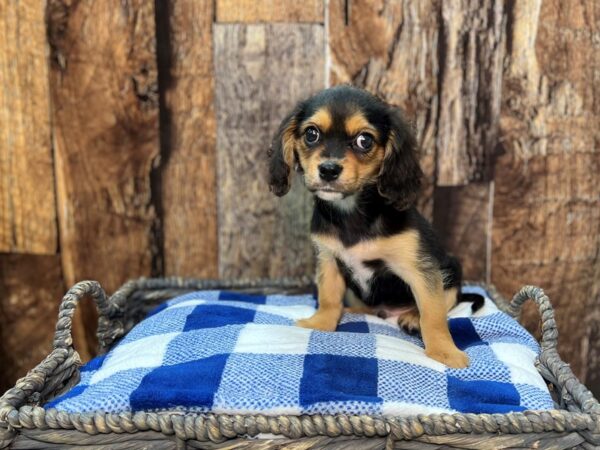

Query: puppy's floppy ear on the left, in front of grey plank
[268,107,298,197]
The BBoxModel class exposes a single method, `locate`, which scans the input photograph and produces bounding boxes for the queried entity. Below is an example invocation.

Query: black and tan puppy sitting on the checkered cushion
[269,86,469,368]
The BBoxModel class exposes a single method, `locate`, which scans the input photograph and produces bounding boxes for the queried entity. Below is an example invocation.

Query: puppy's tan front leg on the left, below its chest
[296,252,346,331]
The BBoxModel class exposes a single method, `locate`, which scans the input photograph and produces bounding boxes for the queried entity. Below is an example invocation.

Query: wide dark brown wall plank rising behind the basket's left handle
[48,0,159,356]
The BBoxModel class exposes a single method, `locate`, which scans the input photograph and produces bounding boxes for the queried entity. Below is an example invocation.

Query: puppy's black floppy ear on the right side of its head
[377,106,423,210]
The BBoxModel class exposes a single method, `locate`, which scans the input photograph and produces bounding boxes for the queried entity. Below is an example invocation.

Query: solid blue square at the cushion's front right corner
[448,376,525,414]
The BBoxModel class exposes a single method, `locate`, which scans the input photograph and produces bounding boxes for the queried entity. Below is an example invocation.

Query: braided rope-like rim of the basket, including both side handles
[0,277,600,448]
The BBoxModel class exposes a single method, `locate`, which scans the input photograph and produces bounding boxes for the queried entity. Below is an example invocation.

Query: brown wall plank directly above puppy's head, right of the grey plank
[328,0,440,218]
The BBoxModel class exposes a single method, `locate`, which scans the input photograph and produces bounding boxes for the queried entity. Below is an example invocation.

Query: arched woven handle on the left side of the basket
[53,281,117,349]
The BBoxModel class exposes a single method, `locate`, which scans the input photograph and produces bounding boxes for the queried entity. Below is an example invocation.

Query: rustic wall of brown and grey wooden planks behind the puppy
[0,0,600,400]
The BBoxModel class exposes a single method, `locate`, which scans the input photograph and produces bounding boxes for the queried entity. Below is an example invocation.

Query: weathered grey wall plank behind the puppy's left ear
[214,24,324,277]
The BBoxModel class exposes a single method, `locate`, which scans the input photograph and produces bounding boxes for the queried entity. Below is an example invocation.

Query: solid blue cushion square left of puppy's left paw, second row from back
[183,304,256,331]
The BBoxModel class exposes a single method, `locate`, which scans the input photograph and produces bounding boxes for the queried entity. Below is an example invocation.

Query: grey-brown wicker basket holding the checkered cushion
[0,278,600,449]
